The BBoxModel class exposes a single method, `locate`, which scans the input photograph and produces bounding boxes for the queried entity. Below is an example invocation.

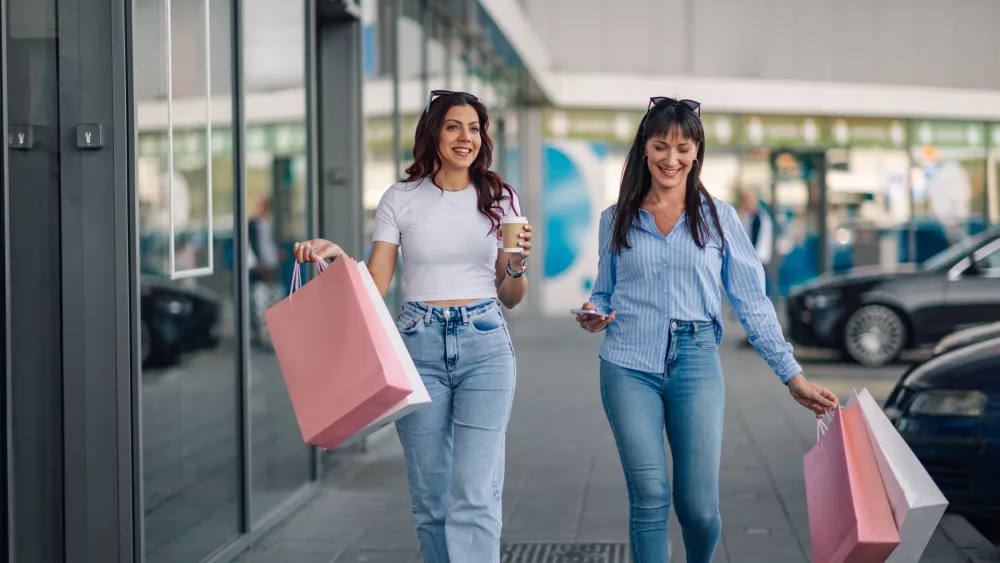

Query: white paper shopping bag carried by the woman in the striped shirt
[849,389,948,563]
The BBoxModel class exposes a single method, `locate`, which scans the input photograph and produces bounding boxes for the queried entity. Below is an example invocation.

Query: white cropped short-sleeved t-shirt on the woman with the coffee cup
[372,178,521,301]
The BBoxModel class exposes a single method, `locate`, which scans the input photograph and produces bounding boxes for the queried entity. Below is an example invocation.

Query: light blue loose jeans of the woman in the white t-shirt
[396,299,515,563]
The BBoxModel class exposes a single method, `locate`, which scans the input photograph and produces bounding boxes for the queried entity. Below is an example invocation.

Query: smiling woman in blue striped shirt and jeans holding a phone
[577,97,836,563]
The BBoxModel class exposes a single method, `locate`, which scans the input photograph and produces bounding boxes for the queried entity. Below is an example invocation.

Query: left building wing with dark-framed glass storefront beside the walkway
[0,0,531,563]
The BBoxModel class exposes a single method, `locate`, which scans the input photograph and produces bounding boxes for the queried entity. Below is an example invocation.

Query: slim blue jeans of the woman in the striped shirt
[601,321,725,563]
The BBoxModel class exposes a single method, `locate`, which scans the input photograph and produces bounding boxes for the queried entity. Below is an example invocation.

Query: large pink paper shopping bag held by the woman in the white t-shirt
[264,258,413,449]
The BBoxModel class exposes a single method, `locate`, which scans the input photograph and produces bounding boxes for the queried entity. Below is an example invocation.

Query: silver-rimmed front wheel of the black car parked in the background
[844,305,906,367]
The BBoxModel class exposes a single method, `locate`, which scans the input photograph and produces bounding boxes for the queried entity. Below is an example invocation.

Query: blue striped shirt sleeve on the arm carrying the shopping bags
[718,203,802,383]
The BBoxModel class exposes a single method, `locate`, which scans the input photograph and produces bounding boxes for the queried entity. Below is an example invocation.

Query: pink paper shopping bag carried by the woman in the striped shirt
[804,404,899,563]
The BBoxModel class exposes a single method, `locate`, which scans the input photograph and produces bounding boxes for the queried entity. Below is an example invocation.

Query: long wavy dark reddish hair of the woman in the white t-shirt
[405,92,516,234]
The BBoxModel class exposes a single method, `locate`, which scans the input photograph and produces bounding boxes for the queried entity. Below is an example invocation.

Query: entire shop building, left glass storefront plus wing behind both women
[0,0,1000,563]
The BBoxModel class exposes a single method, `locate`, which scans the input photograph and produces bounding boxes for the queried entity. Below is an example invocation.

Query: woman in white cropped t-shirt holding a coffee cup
[295,90,531,563]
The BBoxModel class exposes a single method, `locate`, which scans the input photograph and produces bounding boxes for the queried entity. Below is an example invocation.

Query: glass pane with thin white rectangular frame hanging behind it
[133,0,240,563]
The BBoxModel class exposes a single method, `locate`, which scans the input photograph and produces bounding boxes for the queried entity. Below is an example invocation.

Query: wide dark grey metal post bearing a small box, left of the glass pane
[56,0,138,563]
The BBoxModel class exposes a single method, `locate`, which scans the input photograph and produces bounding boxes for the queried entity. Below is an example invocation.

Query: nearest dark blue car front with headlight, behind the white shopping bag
[884,338,1000,521]
